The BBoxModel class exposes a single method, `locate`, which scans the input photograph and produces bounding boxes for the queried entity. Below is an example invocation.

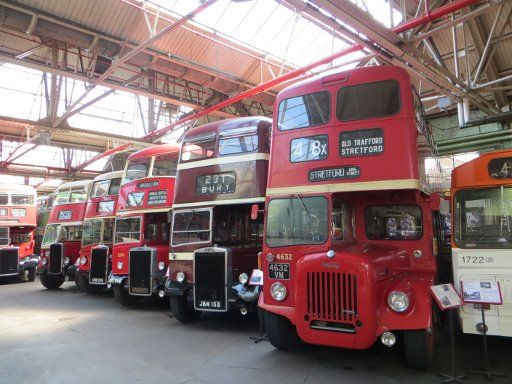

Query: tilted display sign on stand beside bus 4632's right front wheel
[430,284,467,383]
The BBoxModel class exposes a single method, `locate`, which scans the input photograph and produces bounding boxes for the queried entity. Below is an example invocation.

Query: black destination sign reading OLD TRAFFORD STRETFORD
[340,128,384,157]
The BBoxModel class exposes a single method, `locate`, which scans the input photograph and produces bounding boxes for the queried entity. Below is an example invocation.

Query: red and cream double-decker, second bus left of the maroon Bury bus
[78,171,123,293]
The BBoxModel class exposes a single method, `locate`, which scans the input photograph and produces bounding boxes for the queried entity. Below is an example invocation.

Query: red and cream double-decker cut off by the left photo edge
[0,184,39,281]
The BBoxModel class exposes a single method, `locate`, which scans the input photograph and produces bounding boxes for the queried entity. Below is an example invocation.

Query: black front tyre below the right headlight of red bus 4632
[403,329,435,371]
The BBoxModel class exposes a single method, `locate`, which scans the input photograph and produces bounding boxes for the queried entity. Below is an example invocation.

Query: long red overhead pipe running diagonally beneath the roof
[142,0,479,140]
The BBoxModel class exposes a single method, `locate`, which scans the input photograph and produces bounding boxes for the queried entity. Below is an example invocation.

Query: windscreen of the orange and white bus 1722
[454,186,512,248]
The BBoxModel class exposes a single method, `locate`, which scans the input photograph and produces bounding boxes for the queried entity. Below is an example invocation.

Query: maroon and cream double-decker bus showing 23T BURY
[167,117,272,322]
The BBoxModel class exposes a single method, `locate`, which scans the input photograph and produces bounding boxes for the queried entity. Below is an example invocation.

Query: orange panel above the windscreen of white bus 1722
[452,149,512,188]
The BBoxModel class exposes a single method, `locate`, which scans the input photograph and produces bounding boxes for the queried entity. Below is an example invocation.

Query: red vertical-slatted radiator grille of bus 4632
[306,272,358,322]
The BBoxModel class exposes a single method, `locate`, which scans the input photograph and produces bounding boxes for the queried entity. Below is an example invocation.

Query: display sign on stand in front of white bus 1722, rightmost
[460,280,508,381]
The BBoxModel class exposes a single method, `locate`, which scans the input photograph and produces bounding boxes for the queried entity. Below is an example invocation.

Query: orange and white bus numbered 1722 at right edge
[451,149,512,337]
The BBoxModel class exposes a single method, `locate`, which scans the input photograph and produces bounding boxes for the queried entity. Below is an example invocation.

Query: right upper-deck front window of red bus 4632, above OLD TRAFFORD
[336,80,400,121]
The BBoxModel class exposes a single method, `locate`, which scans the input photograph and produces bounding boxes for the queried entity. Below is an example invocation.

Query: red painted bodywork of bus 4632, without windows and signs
[259,66,439,349]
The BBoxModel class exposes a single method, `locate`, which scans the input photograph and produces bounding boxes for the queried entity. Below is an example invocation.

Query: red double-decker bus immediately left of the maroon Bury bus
[109,144,179,305]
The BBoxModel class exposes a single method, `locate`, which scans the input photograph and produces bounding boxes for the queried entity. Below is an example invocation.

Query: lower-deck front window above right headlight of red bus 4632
[364,205,423,240]
